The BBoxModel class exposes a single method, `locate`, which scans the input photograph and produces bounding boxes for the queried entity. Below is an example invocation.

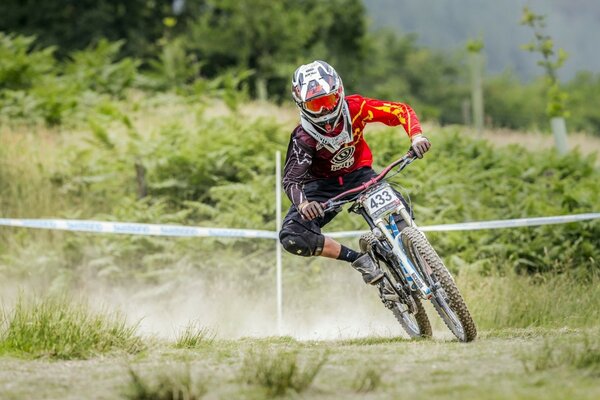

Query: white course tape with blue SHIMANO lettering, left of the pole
[0,218,277,239]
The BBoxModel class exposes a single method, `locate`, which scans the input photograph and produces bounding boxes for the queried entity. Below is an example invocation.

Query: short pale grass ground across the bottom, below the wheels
[0,329,600,399]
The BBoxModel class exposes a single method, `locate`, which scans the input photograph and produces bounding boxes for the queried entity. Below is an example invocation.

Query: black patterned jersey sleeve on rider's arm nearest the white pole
[283,135,313,207]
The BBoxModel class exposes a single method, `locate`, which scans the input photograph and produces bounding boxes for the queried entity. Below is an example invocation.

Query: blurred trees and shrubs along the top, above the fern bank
[0,0,600,135]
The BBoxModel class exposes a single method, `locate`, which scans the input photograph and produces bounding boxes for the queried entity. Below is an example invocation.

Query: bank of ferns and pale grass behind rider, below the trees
[0,89,600,288]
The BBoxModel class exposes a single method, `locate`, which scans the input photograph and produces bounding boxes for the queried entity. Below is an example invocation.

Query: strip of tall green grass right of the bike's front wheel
[457,273,600,329]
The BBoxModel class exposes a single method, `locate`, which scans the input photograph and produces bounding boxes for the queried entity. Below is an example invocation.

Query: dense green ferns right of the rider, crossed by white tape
[390,131,600,273]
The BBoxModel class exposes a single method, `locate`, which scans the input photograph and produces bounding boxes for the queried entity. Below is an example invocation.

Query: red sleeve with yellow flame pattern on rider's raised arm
[355,97,422,138]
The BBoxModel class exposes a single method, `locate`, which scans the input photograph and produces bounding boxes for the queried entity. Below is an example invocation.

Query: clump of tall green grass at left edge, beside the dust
[0,297,145,359]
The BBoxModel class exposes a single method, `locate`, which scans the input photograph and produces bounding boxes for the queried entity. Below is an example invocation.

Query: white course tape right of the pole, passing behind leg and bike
[326,213,600,238]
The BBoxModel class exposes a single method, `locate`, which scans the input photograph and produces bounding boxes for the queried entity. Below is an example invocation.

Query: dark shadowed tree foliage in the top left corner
[0,0,195,57]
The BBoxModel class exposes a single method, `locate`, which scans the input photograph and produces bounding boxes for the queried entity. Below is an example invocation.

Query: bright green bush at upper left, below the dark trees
[0,32,140,125]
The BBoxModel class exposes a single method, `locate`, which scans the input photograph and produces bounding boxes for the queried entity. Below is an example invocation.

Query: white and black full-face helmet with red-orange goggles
[292,60,352,150]
